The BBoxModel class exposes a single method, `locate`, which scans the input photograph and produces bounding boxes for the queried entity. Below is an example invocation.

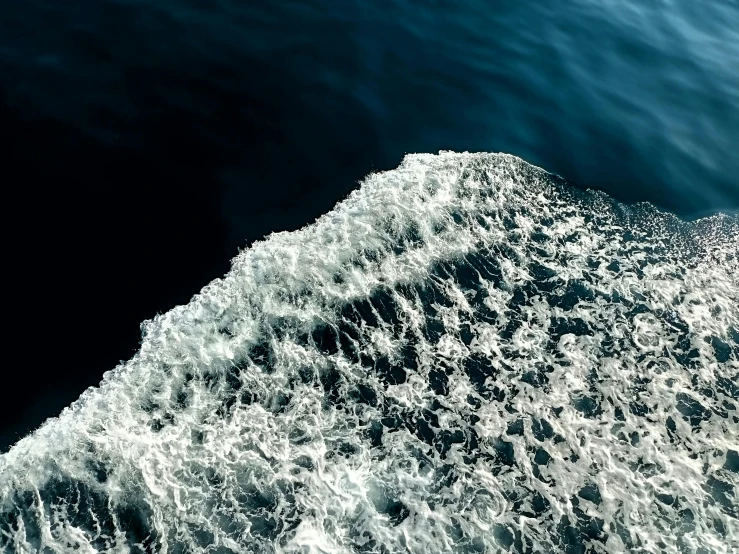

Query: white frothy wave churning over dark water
[0,152,739,554]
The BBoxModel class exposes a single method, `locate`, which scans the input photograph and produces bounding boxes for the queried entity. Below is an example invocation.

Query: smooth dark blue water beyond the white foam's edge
[0,0,739,447]
